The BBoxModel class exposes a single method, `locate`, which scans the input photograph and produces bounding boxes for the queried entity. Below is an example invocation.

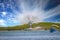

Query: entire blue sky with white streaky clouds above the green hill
[0,0,60,26]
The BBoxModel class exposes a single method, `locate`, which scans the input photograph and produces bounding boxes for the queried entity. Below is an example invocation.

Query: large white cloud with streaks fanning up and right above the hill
[12,0,60,24]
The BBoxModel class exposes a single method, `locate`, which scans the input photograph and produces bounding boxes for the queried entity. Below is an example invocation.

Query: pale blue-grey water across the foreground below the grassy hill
[0,30,60,40]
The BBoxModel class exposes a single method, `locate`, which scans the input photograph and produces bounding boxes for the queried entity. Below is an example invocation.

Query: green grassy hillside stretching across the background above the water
[0,22,60,30]
